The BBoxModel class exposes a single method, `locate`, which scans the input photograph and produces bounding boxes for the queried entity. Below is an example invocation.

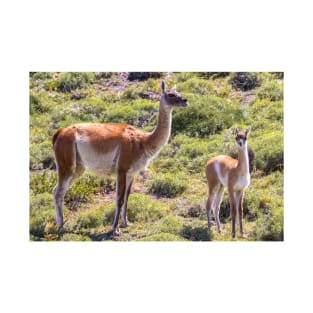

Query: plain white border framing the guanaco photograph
[0,0,312,312]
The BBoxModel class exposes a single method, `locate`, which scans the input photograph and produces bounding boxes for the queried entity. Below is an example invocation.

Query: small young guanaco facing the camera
[205,127,251,238]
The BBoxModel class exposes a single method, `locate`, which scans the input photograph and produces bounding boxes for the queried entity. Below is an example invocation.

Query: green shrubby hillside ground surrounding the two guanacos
[29,72,284,241]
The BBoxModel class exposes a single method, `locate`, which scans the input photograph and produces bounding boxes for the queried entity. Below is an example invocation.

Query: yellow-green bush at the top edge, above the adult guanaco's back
[57,72,95,92]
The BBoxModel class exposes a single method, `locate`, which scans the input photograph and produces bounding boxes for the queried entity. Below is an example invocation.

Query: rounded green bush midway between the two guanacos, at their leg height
[148,174,188,198]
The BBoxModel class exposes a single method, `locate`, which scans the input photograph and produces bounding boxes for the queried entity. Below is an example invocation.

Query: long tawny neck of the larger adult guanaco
[147,103,172,153]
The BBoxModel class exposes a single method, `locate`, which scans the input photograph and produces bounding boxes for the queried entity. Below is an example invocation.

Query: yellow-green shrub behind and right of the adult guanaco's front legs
[103,193,167,225]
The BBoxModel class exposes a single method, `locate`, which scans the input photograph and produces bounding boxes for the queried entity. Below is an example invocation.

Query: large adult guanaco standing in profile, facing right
[53,81,187,236]
